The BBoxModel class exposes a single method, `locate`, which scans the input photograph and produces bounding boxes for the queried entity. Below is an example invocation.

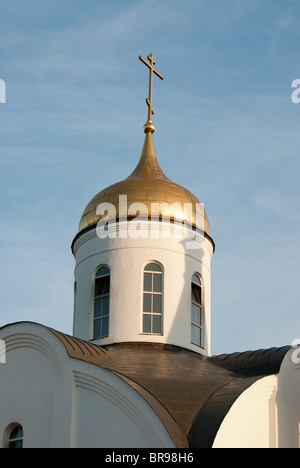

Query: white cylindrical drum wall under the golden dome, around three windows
[73,222,213,354]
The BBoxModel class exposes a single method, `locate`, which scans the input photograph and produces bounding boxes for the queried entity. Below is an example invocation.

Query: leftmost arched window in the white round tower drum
[94,266,110,338]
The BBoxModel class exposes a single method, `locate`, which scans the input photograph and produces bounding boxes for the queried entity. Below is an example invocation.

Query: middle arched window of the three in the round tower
[143,263,163,335]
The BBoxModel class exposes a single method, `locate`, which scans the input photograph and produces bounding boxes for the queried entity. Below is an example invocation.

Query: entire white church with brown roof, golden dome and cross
[0,54,300,449]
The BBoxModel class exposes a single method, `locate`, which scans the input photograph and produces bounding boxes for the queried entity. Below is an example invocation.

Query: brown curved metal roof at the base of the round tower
[50,329,290,448]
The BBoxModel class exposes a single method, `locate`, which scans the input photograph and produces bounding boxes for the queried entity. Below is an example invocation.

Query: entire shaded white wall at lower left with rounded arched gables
[0,323,174,448]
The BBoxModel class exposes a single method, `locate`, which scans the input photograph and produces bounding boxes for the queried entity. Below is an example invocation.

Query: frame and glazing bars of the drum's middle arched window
[141,260,164,336]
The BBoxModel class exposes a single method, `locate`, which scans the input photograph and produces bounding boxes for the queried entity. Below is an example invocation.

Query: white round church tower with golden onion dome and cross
[72,54,214,355]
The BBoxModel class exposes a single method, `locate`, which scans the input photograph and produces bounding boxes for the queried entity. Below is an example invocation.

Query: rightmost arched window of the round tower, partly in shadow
[191,274,204,347]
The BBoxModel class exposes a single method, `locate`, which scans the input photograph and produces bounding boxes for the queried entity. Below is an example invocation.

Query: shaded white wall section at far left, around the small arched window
[0,324,72,448]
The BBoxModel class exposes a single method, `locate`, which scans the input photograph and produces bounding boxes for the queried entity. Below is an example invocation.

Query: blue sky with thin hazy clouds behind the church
[0,0,300,353]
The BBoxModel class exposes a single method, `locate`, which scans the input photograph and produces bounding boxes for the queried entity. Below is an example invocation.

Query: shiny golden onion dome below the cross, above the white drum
[79,132,210,236]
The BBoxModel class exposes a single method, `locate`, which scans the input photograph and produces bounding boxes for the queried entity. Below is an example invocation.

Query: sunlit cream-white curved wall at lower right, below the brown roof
[214,348,300,448]
